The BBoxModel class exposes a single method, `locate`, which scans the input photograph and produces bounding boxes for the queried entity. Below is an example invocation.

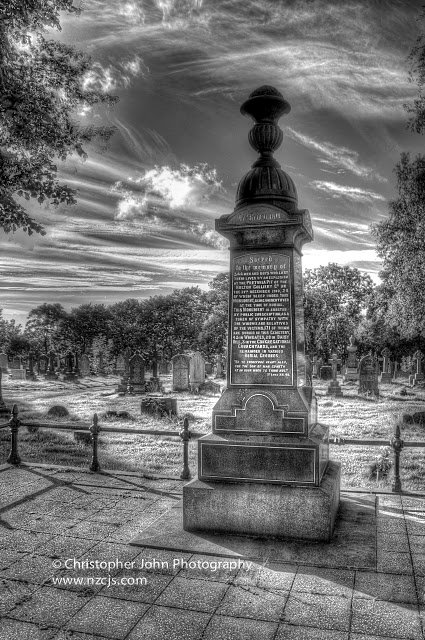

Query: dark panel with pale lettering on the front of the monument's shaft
[230,251,294,386]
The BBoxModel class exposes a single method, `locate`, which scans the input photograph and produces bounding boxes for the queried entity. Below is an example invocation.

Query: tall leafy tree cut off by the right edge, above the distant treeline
[372,153,425,339]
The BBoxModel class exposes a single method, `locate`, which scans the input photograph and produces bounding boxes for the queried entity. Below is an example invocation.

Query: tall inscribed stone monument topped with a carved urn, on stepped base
[183,87,340,540]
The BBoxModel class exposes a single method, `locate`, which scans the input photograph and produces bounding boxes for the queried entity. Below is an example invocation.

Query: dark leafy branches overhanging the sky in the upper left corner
[0,0,117,234]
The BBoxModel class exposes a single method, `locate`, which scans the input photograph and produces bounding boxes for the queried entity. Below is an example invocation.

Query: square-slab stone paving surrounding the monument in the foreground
[0,465,425,640]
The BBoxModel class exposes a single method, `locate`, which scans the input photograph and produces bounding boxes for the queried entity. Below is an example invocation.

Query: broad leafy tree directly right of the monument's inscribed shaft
[304,263,373,359]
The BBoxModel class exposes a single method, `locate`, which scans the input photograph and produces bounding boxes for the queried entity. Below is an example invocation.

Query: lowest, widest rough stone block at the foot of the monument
[183,462,341,542]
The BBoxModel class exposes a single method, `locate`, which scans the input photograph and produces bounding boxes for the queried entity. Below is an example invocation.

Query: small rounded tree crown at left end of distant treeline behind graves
[24,302,68,354]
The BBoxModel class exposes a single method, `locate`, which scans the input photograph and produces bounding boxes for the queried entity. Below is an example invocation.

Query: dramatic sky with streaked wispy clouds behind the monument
[0,0,424,322]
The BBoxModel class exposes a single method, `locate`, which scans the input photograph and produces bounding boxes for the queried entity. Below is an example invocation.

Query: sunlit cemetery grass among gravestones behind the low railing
[0,376,425,491]
